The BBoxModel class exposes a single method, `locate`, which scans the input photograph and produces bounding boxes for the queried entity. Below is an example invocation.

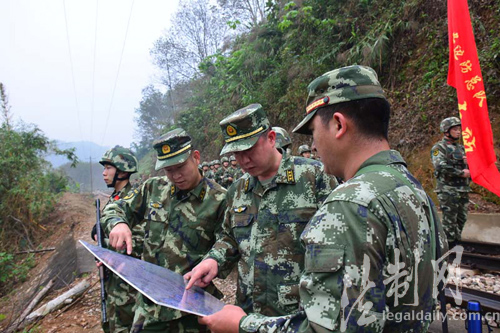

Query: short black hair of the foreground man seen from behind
[316,98,391,140]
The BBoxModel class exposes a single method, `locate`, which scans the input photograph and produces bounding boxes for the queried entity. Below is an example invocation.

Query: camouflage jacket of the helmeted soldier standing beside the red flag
[431,137,470,193]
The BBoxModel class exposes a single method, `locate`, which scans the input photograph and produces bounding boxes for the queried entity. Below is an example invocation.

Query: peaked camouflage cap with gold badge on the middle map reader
[219,104,270,155]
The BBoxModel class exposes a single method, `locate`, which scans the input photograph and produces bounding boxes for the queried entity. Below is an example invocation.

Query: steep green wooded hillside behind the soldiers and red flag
[133,0,500,203]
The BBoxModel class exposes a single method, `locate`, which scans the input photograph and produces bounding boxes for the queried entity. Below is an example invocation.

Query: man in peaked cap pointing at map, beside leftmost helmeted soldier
[105,128,226,332]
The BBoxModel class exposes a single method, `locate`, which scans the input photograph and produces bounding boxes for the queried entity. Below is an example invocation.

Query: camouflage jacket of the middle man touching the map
[207,156,337,316]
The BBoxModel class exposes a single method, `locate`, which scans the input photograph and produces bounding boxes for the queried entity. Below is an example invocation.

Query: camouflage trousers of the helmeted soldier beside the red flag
[438,192,469,243]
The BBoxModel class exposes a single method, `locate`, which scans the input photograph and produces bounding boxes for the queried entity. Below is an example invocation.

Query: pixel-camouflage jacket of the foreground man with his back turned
[240,150,447,332]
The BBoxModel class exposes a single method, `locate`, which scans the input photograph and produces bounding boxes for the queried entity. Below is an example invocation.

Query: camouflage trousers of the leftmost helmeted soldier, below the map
[103,272,137,333]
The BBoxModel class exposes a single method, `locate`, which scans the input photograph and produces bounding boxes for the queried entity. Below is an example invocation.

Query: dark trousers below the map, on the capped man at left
[130,313,209,333]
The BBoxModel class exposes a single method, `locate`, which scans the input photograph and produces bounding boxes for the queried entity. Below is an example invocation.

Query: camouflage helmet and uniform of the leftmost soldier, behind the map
[97,146,143,332]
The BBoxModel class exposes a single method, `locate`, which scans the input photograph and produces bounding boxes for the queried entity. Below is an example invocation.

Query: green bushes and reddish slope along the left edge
[0,83,77,294]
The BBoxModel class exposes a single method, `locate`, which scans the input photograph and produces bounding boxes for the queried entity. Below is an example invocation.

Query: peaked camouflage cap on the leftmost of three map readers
[153,128,192,170]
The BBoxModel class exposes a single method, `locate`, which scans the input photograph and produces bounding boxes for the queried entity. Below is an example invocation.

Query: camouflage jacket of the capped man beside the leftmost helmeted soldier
[101,177,226,321]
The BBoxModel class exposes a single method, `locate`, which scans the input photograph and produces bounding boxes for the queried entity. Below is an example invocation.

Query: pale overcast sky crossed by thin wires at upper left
[0,0,178,147]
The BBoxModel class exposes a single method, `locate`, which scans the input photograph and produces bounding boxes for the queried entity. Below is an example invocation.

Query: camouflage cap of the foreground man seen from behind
[293,65,385,135]
